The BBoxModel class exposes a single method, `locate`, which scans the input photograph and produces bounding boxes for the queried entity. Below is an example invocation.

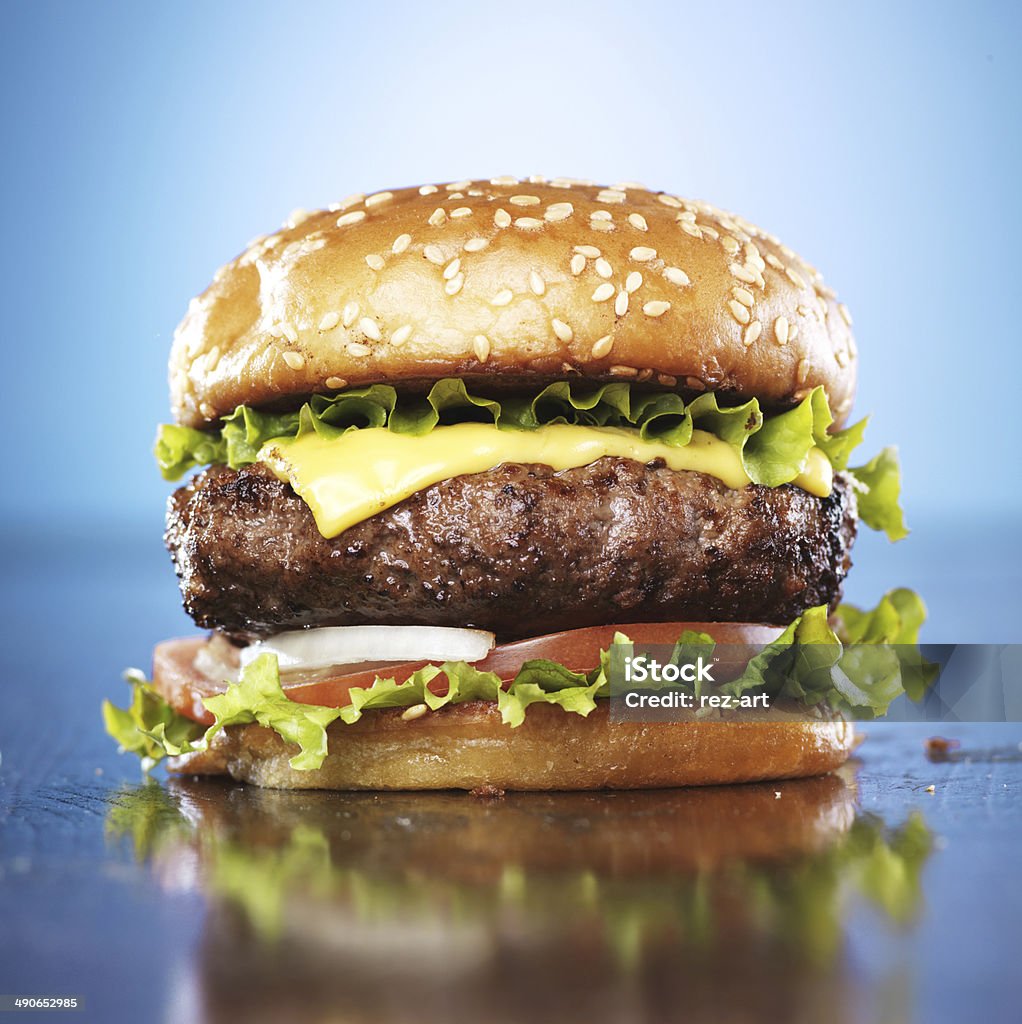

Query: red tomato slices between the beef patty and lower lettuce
[153,623,783,725]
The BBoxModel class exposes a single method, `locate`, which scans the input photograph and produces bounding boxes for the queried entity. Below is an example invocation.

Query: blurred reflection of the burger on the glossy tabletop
[108,775,932,1022]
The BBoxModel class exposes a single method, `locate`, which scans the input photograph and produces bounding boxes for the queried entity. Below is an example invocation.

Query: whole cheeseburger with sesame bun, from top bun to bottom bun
[104,178,923,790]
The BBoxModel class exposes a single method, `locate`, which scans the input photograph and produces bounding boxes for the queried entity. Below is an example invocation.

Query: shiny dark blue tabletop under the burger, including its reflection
[0,524,1022,1024]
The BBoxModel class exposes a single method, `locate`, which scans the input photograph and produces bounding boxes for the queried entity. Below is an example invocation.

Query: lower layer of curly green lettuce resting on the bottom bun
[103,590,936,771]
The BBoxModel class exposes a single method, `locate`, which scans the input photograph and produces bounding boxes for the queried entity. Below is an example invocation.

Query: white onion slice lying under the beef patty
[242,626,495,671]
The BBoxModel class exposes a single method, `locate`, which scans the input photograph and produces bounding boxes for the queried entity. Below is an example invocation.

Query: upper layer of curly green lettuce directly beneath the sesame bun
[154,378,906,540]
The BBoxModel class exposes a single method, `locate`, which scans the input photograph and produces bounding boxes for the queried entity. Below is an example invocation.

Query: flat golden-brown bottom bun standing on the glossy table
[170,700,855,791]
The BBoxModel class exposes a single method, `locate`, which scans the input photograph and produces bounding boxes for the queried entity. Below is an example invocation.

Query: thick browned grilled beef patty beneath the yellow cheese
[166,458,856,640]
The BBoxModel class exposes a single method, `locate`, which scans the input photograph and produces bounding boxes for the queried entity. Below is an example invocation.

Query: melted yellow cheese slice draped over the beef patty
[259,423,833,537]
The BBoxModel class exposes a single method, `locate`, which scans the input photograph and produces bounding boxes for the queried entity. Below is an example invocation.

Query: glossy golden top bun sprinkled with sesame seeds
[170,178,856,426]
